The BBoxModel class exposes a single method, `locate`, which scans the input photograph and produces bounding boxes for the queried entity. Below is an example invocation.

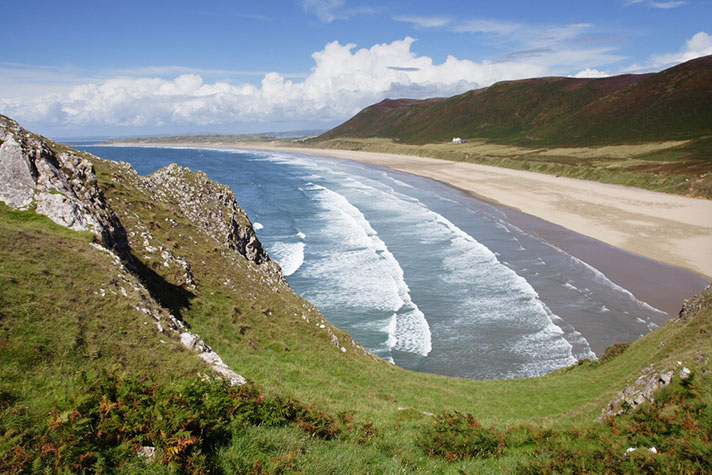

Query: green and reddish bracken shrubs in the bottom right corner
[516,375,712,474]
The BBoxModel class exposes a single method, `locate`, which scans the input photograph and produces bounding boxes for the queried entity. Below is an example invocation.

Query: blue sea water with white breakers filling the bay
[82,146,667,379]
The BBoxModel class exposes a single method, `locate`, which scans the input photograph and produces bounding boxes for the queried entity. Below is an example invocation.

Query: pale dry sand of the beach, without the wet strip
[264,148,712,281]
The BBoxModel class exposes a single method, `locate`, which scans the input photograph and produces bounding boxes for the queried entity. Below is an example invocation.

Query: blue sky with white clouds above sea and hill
[0,0,712,138]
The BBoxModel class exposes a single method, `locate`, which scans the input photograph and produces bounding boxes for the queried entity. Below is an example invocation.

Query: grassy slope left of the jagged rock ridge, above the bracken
[0,204,209,417]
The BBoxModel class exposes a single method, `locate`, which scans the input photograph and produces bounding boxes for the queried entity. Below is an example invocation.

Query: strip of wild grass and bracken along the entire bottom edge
[0,360,712,474]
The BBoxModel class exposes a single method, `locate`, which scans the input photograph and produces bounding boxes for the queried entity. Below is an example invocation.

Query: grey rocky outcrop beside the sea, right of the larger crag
[146,164,277,270]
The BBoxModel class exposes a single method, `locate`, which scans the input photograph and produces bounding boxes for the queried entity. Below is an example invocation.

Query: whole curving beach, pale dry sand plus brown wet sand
[96,143,712,315]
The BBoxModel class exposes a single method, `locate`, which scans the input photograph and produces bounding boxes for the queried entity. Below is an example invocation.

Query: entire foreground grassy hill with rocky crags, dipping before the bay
[0,116,712,473]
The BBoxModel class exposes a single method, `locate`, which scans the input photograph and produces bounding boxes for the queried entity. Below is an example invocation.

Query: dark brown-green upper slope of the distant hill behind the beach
[317,56,712,146]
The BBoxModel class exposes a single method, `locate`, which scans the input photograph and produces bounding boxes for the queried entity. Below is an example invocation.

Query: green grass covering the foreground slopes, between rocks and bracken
[0,145,712,473]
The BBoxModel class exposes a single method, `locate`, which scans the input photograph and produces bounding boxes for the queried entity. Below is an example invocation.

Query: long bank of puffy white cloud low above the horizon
[0,37,550,131]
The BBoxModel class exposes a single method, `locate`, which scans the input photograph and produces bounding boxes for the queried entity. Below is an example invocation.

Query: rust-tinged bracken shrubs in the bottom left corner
[0,373,340,473]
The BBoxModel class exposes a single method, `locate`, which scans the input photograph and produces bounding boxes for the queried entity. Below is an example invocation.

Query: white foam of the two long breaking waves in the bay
[245,149,593,368]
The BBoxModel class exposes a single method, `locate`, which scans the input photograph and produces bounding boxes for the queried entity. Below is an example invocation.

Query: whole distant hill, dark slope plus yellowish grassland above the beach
[306,56,712,198]
